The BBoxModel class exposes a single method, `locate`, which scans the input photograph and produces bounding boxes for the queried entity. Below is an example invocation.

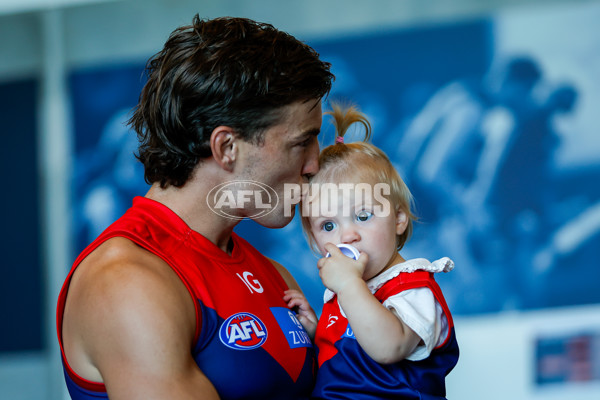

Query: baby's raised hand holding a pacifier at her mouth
[317,243,369,293]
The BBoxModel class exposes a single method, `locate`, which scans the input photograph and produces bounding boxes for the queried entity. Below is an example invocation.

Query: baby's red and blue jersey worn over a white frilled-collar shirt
[312,271,458,400]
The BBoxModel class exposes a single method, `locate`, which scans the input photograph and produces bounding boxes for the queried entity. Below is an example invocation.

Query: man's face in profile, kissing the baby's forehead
[238,99,322,228]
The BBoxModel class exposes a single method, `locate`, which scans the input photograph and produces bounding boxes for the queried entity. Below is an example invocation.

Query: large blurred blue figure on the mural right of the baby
[397,56,577,312]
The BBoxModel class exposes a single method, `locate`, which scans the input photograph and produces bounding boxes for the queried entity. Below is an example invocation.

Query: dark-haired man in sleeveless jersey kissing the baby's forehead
[57,16,333,400]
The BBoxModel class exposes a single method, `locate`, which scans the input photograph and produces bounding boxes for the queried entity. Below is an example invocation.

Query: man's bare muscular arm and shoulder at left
[63,238,219,400]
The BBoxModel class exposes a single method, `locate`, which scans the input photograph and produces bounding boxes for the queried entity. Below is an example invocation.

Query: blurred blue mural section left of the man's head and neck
[69,64,148,253]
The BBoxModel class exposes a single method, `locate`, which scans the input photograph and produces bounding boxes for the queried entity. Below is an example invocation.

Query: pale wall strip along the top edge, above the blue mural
[0,0,585,81]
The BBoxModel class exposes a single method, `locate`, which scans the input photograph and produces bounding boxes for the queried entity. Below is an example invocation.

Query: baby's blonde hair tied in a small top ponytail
[302,103,417,253]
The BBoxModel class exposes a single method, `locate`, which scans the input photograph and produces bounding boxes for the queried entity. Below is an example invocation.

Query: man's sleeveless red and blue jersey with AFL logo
[57,197,317,400]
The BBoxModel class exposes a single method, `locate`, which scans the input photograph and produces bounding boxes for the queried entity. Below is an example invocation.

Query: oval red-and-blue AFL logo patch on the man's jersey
[219,313,267,350]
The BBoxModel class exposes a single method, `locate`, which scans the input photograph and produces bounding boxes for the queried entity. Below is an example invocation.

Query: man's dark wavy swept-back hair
[129,15,334,188]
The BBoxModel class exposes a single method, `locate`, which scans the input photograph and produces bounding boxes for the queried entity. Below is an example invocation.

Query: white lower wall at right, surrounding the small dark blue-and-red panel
[447,306,600,400]
